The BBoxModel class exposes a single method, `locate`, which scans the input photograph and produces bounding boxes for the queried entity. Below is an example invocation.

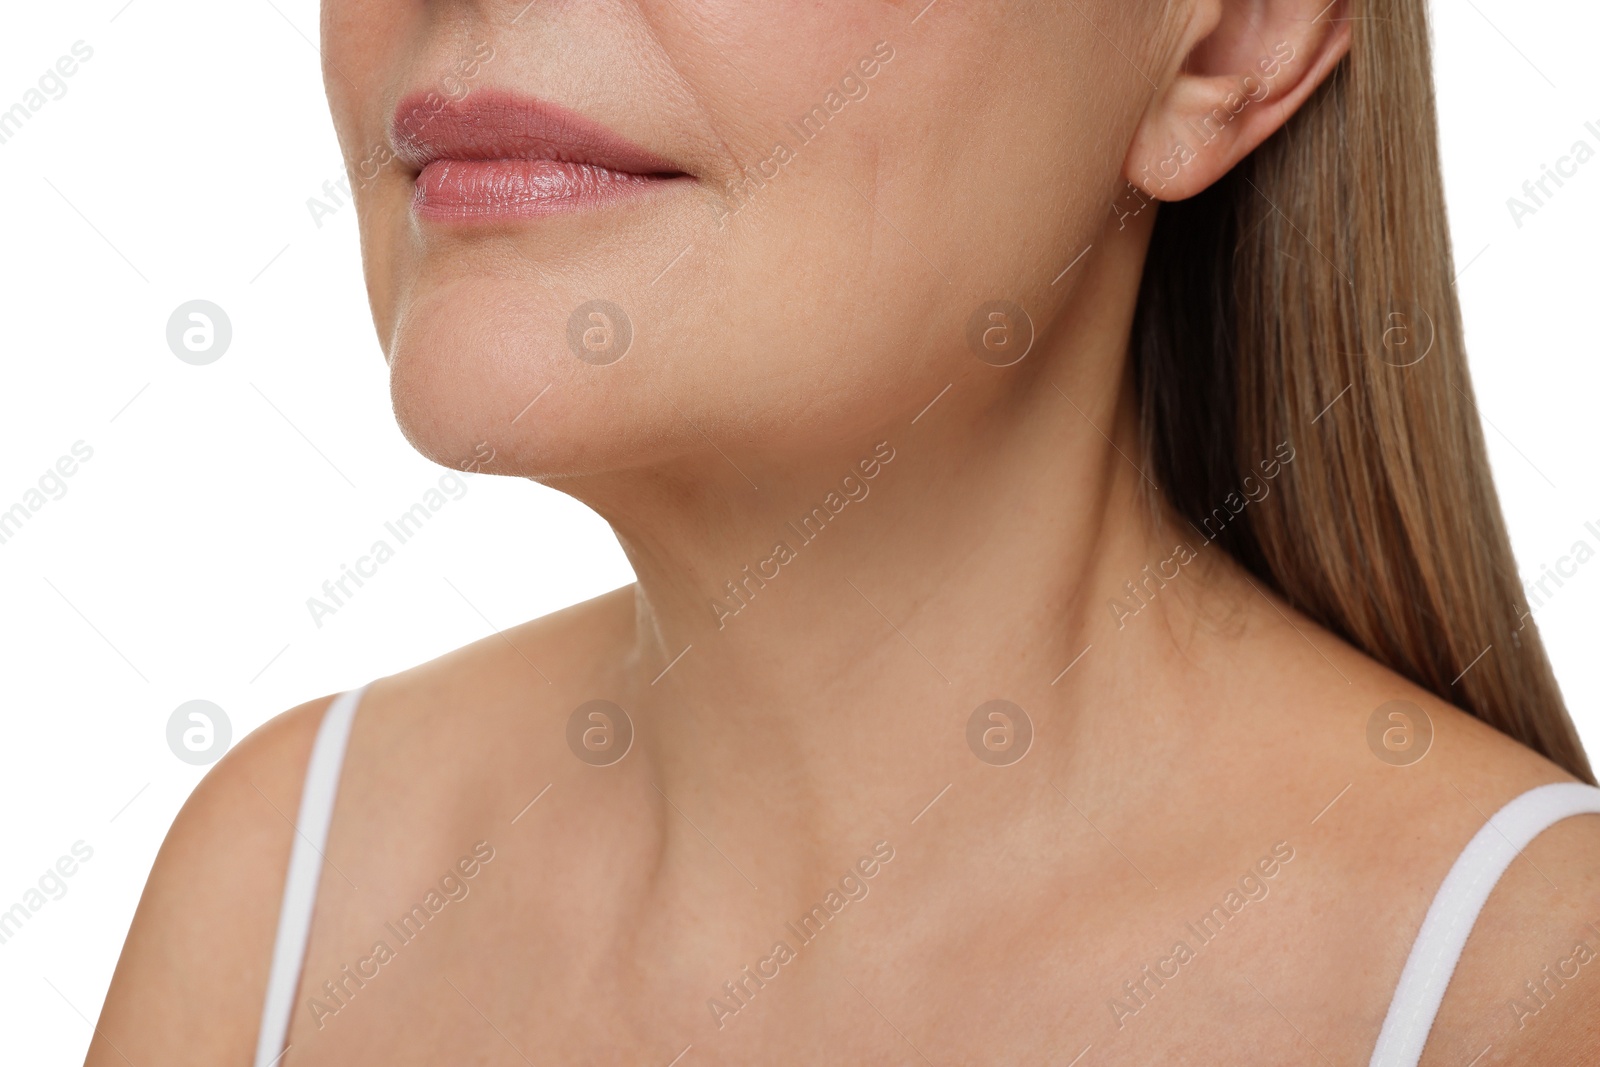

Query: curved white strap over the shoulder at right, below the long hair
[1370,782,1600,1067]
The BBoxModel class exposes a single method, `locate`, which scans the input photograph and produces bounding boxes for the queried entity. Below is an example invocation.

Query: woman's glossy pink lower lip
[411,160,672,222]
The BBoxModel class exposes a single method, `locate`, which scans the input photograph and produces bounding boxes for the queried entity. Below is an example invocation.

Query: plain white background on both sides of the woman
[0,0,1600,1067]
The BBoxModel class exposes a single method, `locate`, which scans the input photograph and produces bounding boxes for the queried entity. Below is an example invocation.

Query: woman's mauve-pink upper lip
[389,88,683,176]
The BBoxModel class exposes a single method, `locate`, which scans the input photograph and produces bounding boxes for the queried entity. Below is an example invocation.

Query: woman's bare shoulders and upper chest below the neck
[88,575,1600,1065]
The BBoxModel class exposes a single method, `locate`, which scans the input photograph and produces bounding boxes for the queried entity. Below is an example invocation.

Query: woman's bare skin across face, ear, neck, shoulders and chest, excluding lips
[88,0,1600,1067]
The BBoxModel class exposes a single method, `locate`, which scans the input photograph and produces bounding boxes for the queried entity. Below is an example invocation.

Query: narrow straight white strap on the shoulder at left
[256,686,365,1067]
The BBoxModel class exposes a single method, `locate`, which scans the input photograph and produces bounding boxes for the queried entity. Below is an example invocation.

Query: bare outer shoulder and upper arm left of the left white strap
[86,687,331,1067]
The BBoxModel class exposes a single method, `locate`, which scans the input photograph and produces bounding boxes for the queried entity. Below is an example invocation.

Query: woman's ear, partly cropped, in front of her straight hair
[1123,0,1350,200]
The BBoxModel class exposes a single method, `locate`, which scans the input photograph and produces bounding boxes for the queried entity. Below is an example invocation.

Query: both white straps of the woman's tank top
[246,689,1600,1067]
